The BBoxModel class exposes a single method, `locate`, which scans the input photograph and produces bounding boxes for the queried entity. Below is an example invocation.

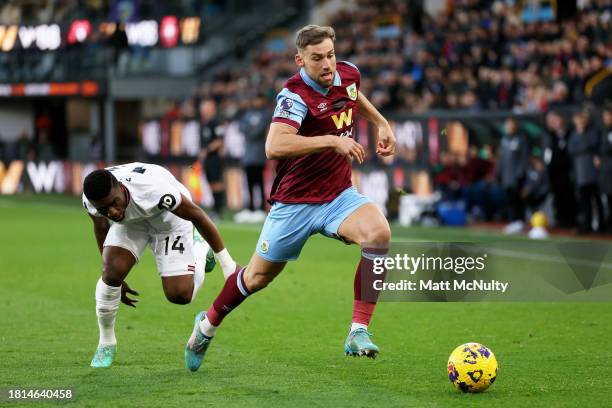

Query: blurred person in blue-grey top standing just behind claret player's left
[239,94,272,221]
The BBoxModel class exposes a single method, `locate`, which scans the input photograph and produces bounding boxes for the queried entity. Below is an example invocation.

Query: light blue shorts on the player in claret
[257,187,370,262]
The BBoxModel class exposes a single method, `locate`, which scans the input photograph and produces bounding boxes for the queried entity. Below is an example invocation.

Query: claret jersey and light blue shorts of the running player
[257,62,369,262]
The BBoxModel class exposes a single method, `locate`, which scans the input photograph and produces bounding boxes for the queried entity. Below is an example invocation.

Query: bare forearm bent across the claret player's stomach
[266,123,365,163]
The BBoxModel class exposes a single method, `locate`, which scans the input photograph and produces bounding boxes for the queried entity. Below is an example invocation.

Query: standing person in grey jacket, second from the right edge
[569,109,603,234]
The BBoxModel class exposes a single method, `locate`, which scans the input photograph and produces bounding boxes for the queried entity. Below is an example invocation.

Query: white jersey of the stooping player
[83,162,191,231]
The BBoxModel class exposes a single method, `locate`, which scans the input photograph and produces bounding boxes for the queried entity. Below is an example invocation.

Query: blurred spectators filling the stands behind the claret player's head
[198,0,612,115]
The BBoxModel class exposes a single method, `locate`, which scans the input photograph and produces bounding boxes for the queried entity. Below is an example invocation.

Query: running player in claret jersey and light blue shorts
[185,25,395,371]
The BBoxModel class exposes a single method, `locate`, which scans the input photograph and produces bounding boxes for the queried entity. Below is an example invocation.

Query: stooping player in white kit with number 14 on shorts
[83,163,239,368]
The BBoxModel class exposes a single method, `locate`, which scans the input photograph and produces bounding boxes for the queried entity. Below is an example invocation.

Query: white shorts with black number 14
[104,221,203,277]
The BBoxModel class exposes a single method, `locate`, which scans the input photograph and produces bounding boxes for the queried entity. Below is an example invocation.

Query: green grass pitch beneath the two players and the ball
[0,196,612,407]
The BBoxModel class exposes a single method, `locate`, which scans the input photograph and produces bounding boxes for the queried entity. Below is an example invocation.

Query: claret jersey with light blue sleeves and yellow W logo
[270,61,361,203]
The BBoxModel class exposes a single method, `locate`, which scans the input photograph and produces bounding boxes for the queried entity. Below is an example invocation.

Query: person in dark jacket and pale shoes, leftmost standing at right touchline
[496,118,529,234]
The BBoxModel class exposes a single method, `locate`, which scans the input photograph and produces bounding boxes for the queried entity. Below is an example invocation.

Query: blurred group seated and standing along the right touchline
[433,103,612,234]
